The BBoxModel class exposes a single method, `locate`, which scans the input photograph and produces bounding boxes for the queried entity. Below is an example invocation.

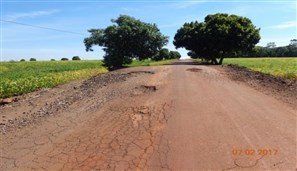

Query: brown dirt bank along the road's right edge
[222,65,297,109]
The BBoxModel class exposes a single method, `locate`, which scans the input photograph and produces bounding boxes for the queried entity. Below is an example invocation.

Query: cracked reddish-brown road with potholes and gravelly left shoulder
[0,62,297,171]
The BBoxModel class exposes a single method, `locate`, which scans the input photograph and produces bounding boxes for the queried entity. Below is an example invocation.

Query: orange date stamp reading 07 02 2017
[232,149,278,156]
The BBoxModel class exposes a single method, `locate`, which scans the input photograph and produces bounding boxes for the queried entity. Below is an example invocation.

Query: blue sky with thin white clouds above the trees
[0,0,297,61]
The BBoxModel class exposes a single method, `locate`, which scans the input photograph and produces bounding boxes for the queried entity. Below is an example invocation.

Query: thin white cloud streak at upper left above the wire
[4,9,60,21]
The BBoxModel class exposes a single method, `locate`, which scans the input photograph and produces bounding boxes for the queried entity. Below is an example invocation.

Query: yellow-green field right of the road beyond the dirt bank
[224,58,297,80]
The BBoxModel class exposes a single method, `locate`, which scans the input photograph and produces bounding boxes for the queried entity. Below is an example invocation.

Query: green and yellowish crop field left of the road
[0,60,107,98]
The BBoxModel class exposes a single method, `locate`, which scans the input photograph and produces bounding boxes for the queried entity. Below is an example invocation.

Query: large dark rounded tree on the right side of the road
[173,13,260,64]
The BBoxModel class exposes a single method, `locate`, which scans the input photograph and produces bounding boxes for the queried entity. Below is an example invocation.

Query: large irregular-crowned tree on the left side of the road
[84,15,168,69]
